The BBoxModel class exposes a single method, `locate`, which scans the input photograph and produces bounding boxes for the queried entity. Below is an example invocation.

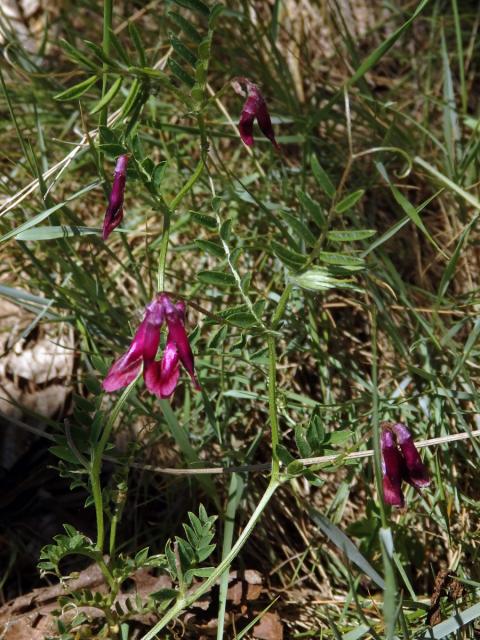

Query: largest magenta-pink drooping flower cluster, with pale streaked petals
[103,293,200,398]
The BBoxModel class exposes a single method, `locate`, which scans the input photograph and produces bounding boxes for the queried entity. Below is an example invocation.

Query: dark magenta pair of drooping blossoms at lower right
[380,422,430,507]
